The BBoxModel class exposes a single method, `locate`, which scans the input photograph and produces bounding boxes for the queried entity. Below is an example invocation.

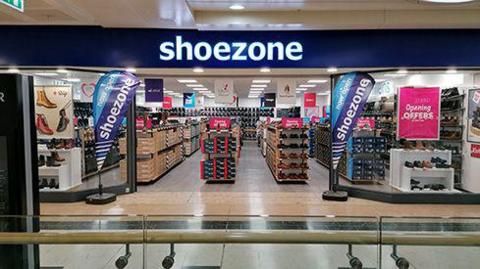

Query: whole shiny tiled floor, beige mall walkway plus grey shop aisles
[41,143,480,217]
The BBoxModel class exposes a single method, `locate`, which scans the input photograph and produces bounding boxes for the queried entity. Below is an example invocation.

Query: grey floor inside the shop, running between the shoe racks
[139,141,328,193]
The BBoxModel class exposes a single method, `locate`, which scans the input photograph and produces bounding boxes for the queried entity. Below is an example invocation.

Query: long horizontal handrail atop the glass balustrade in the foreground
[0,230,480,246]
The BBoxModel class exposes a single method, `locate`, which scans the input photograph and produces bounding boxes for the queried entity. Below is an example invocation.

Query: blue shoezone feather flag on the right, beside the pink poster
[332,72,375,169]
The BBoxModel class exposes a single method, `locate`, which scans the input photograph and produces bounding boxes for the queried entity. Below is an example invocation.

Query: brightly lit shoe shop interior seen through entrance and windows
[22,69,480,203]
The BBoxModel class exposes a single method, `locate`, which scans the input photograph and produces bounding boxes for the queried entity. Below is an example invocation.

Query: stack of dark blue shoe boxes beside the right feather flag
[346,136,386,181]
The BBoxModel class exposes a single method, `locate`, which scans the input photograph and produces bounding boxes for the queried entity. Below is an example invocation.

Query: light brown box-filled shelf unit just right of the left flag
[120,125,184,184]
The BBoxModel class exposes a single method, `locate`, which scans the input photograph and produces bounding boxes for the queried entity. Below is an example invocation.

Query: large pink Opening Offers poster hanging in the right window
[397,87,440,140]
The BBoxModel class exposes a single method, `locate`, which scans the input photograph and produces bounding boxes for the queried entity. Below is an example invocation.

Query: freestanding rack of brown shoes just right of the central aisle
[266,124,309,183]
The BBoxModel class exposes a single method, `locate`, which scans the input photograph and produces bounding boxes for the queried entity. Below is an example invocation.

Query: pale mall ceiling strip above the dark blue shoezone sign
[0,0,480,30]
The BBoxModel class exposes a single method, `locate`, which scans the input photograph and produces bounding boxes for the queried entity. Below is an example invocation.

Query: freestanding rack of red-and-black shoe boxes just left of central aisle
[200,126,240,183]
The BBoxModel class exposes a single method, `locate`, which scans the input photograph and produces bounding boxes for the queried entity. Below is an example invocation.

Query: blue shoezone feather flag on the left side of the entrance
[93,71,140,171]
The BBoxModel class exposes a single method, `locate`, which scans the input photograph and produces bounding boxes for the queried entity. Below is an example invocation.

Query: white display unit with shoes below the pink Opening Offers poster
[389,149,459,193]
